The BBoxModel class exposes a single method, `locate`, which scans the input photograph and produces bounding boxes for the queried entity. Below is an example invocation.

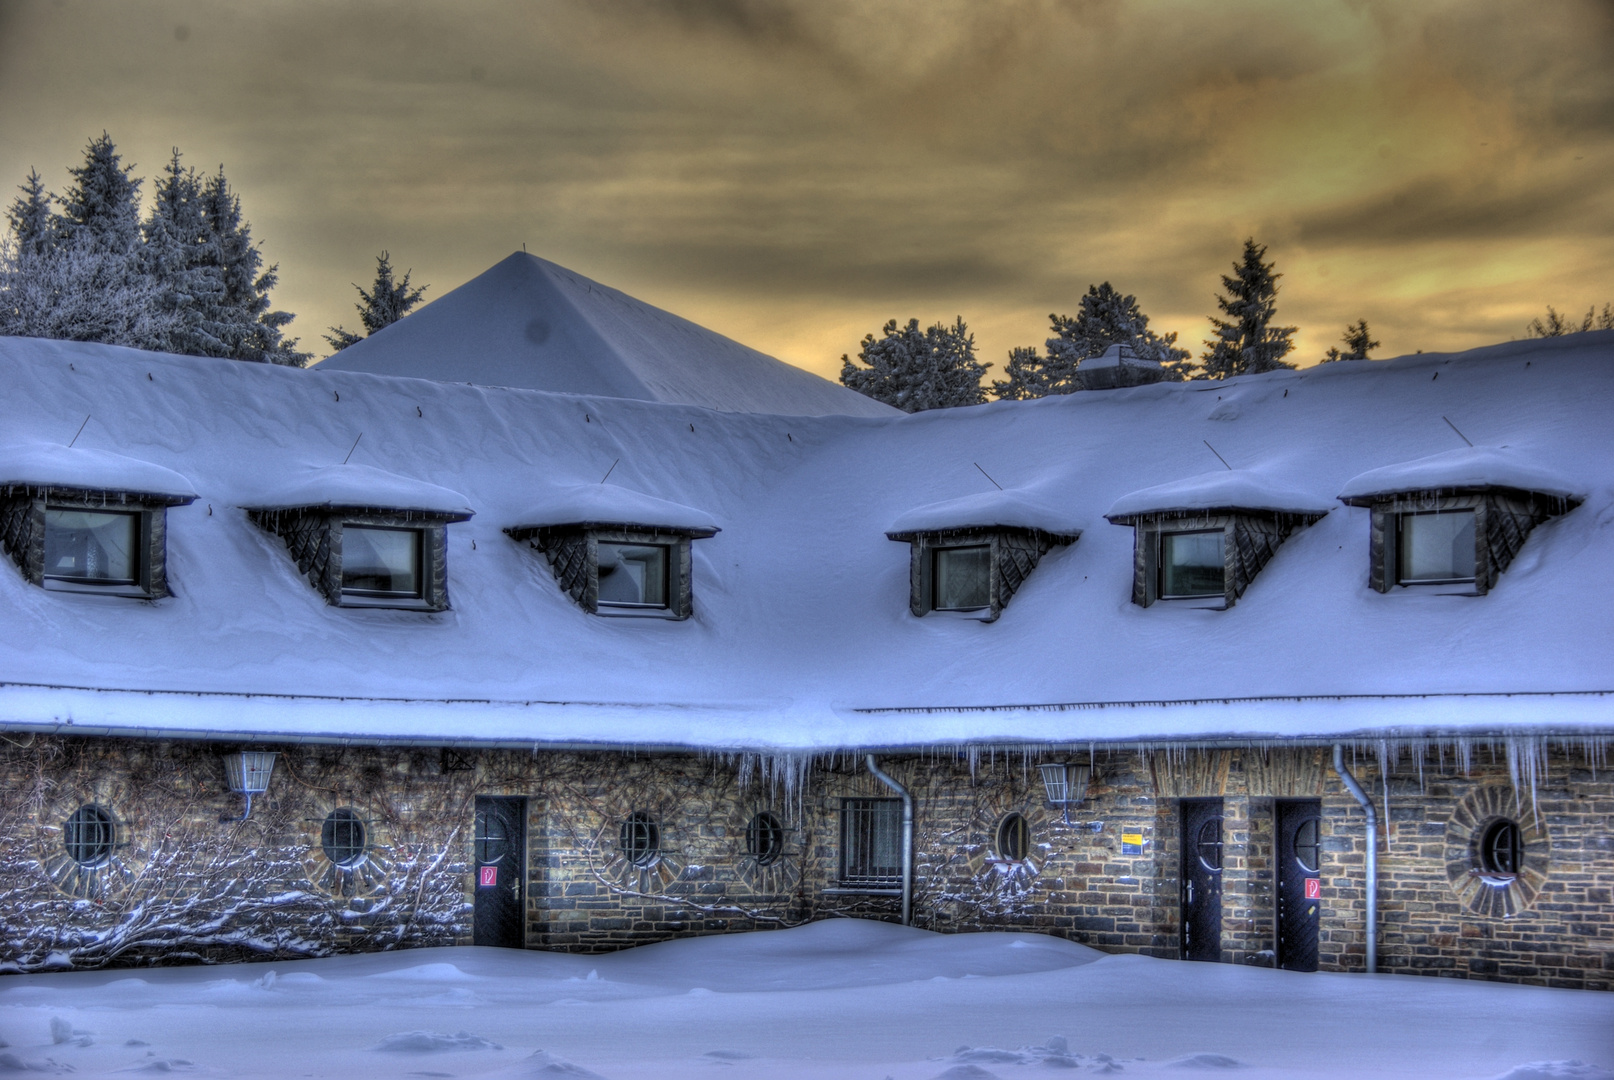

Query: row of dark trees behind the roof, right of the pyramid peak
[841,237,1614,412]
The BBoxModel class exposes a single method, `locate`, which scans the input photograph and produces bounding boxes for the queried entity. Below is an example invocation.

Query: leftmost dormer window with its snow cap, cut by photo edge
[0,446,195,599]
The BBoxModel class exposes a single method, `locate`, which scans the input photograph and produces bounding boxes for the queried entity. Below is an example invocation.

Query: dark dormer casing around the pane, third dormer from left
[505,521,712,620]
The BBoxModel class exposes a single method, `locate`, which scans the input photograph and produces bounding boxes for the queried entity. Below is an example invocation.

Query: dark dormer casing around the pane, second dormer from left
[247,507,470,612]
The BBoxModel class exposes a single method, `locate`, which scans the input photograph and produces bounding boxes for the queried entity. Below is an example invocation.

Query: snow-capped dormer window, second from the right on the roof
[1106,470,1328,607]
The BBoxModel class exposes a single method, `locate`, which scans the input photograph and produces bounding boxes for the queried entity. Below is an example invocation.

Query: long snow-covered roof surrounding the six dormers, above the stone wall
[0,333,1614,751]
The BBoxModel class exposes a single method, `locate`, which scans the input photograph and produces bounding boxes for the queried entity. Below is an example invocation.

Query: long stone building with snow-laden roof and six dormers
[0,270,1614,988]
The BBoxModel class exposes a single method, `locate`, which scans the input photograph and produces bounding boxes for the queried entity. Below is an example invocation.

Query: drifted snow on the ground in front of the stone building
[0,920,1614,1080]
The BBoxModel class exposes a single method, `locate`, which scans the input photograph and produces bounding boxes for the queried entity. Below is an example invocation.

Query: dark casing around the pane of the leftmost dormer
[0,484,192,601]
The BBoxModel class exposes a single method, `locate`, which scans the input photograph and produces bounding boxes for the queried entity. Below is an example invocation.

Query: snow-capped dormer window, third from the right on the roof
[886,489,1081,623]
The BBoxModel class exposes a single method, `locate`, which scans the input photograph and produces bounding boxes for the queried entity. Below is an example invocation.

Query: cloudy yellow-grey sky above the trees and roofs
[0,0,1614,375]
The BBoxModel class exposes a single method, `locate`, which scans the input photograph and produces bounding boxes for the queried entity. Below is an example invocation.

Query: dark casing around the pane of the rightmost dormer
[1344,488,1578,596]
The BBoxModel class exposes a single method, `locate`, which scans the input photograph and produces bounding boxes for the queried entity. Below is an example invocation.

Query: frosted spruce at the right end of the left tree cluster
[202,165,313,366]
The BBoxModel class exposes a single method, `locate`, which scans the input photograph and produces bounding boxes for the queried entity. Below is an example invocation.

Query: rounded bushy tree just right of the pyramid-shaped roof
[841,316,993,413]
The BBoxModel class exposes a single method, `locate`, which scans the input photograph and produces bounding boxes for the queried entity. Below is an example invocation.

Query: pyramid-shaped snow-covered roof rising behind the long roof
[320,252,897,417]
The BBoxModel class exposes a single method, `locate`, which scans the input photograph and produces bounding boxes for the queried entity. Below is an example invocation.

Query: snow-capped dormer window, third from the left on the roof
[505,484,718,620]
